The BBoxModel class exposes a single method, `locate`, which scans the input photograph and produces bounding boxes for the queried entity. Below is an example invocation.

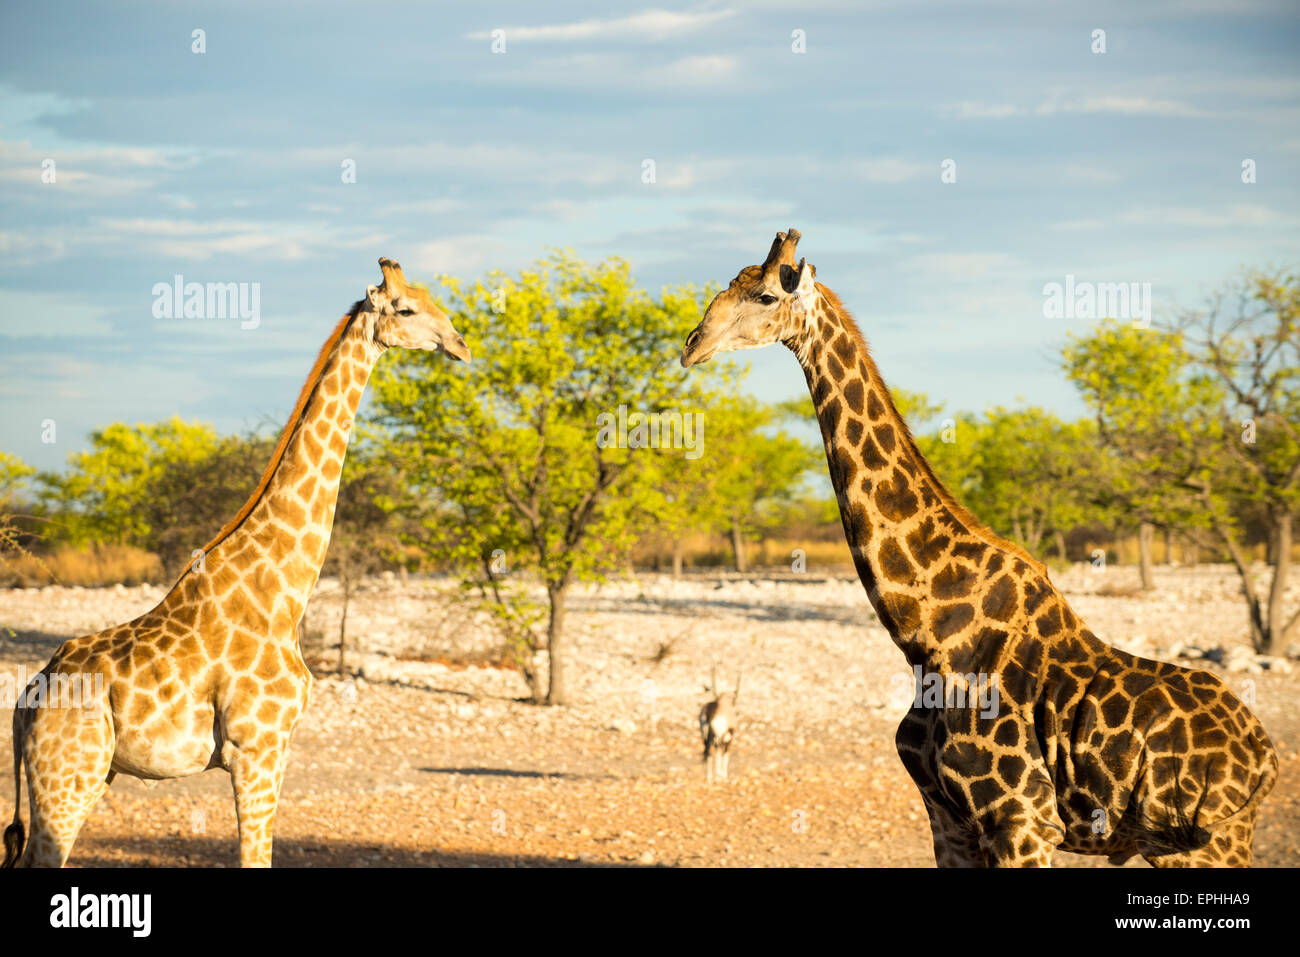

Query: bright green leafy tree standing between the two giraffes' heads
[373,252,733,705]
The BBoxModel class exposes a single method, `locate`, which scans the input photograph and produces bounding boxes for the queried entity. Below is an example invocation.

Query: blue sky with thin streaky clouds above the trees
[0,0,1300,468]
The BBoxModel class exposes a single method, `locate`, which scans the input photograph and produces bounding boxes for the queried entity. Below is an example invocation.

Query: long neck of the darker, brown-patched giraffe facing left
[787,285,1032,671]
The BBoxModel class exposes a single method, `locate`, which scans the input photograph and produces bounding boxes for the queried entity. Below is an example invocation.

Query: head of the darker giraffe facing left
[681,229,816,367]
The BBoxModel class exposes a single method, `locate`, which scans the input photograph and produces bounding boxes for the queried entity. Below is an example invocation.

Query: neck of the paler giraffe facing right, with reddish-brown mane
[169,304,382,641]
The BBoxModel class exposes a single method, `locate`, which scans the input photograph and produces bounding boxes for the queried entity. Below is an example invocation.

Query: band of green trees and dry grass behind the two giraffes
[0,252,1300,686]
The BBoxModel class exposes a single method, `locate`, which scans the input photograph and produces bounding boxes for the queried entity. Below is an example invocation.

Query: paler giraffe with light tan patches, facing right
[4,259,469,867]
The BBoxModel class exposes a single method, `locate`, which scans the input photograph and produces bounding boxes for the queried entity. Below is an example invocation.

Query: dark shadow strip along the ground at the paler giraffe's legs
[69,837,647,867]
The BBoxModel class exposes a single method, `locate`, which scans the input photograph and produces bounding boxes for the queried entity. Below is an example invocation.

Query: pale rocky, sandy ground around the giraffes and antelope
[0,566,1300,867]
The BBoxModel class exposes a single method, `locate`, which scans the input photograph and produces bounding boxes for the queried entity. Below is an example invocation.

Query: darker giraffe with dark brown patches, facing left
[681,229,1278,867]
